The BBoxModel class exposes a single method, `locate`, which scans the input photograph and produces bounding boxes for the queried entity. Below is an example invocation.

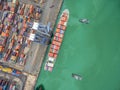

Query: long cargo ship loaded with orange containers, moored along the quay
[44,9,69,72]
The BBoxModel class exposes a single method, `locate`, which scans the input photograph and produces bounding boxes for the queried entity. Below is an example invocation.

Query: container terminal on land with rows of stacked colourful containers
[0,0,63,90]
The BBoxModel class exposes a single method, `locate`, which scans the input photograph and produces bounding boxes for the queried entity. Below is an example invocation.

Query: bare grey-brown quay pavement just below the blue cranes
[24,43,47,75]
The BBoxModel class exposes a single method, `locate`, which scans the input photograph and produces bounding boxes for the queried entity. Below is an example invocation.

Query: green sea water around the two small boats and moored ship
[36,0,120,90]
